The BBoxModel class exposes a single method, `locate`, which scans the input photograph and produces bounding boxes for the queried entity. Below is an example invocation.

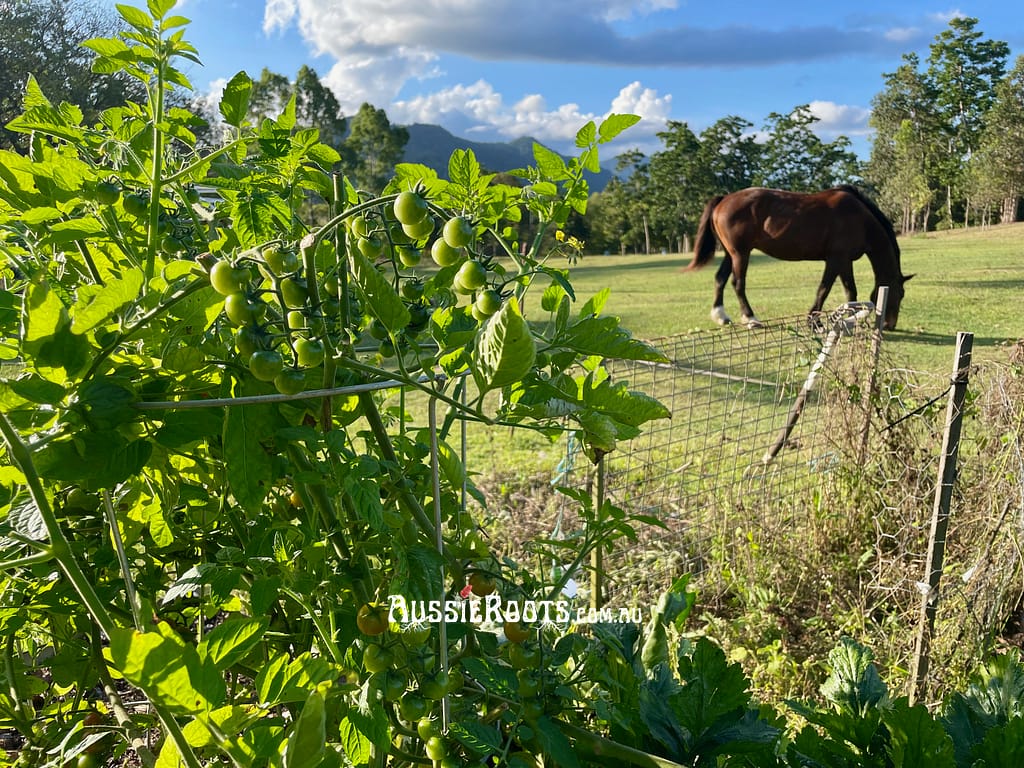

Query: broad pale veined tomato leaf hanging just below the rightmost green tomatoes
[472,296,537,394]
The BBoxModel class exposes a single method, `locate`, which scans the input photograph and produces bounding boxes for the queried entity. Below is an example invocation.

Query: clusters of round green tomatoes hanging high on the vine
[202,190,503,394]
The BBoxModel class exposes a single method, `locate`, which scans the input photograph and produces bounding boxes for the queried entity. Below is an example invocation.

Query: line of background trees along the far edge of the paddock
[0,0,1024,253]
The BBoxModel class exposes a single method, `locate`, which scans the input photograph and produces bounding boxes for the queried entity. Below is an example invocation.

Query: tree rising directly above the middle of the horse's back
[757,104,860,191]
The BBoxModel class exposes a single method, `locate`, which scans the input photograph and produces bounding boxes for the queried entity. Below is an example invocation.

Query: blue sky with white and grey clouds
[151,0,1024,157]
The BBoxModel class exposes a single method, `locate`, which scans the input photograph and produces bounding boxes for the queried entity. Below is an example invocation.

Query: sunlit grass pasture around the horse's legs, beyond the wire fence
[571,223,1024,373]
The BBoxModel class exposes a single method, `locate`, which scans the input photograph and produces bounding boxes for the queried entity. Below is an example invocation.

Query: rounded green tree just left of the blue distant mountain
[341,103,409,191]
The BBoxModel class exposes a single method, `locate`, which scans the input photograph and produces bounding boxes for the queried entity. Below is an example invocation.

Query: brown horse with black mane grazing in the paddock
[686,185,913,329]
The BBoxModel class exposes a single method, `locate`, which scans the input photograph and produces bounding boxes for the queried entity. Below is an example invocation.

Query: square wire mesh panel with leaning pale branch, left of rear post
[557,305,877,601]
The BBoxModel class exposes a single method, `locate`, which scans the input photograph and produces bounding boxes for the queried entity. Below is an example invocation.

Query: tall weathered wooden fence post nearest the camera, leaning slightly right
[907,332,974,705]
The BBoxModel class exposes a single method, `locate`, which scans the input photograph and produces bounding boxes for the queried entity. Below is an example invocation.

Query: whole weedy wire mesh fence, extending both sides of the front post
[563,313,1024,700]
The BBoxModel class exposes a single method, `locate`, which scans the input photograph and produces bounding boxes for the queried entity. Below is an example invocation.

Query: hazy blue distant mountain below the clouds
[402,123,612,193]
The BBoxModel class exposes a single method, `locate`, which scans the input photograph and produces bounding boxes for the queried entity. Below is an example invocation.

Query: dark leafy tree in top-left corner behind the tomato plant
[0,0,144,148]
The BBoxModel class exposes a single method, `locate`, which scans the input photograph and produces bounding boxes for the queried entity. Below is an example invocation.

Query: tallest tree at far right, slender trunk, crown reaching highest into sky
[927,16,1010,225]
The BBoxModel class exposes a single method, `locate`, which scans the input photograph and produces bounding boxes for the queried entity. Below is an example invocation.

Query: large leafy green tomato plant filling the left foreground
[0,0,729,768]
